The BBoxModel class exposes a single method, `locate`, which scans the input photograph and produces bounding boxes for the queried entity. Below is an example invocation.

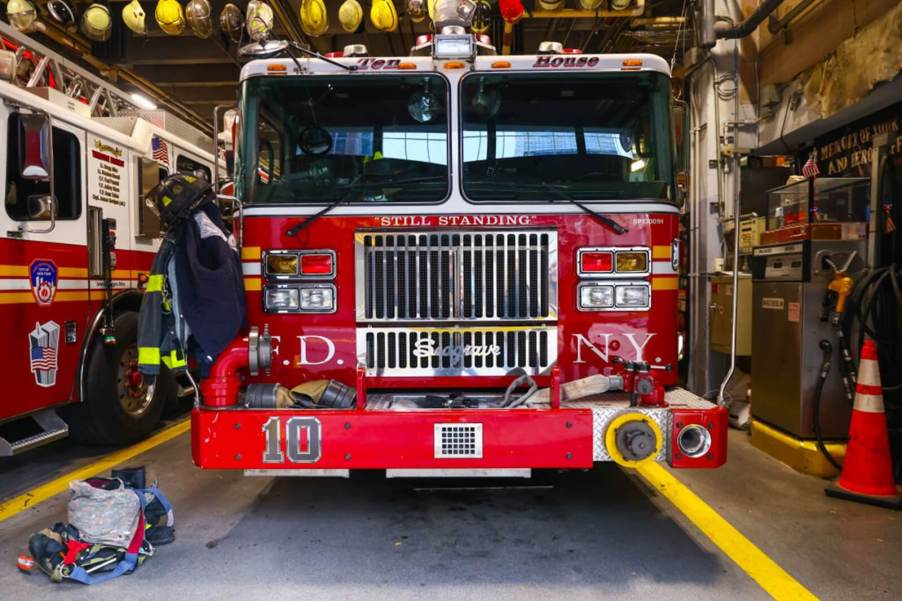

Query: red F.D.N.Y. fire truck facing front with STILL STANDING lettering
[192,29,727,476]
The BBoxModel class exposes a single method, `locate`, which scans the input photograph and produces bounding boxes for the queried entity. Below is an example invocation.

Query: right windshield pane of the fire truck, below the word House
[461,72,673,202]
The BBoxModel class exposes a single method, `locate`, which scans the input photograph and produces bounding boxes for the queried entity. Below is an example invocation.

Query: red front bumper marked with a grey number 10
[191,389,727,471]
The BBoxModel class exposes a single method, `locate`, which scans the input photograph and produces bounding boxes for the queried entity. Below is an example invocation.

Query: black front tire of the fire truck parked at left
[65,311,176,445]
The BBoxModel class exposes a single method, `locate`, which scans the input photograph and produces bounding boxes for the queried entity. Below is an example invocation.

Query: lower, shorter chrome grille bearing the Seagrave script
[357,326,557,376]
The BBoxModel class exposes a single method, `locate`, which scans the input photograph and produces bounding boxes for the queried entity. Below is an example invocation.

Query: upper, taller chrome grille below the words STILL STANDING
[356,231,557,321]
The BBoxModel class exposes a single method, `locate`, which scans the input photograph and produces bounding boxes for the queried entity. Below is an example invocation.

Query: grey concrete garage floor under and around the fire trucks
[0,432,902,601]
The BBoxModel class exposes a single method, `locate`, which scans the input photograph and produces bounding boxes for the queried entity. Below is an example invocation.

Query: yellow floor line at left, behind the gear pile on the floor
[0,419,191,522]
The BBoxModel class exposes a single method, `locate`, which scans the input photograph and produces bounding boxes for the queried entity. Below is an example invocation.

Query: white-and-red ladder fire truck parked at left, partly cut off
[0,24,213,456]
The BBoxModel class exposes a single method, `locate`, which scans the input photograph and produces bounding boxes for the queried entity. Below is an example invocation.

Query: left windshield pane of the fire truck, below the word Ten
[237,74,449,204]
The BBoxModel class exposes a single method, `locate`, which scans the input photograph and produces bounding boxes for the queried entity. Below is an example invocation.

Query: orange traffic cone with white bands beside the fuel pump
[825,339,902,509]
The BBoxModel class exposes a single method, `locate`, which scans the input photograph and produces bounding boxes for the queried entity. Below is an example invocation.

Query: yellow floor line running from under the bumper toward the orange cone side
[636,463,817,600]
